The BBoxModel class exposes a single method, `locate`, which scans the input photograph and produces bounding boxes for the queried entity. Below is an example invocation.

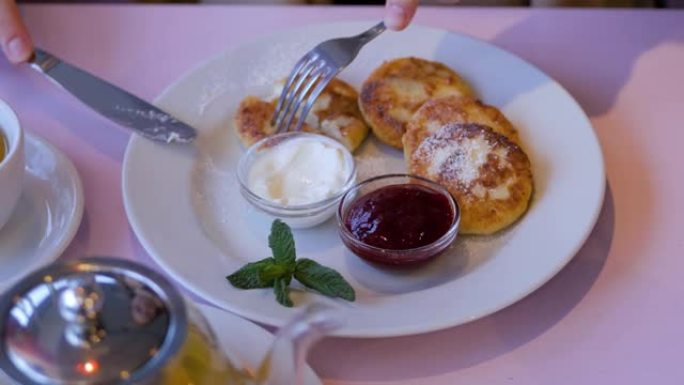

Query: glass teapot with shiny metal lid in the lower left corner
[0,257,341,385]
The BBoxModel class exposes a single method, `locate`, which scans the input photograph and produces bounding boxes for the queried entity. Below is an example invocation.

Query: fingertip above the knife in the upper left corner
[0,0,33,64]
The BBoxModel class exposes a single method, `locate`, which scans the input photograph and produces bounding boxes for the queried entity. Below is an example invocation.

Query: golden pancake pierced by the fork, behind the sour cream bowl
[233,79,370,151]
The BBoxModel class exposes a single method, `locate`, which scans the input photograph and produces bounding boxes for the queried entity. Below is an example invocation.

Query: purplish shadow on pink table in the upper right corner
[492,10,684,116]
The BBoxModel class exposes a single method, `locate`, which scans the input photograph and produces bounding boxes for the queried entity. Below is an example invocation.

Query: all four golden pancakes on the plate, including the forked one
[233,57,533,234]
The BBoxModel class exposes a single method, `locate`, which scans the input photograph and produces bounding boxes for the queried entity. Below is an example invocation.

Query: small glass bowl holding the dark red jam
[337,174,461,266]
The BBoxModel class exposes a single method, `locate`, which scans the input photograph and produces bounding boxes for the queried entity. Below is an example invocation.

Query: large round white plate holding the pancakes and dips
[123,22,605,337]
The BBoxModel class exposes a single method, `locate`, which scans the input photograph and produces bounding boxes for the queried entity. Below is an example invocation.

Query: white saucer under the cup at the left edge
[0,134,83,291]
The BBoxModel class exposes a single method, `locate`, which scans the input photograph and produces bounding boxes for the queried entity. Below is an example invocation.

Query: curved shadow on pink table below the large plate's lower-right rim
[310,186,615,381]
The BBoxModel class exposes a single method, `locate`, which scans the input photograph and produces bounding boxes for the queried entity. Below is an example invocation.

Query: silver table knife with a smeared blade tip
[30,49,197,143]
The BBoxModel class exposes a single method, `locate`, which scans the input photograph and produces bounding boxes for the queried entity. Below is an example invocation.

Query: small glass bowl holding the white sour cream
[237,132,356,229]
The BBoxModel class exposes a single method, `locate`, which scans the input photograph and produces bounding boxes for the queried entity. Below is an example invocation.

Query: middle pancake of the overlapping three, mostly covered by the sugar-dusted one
[402,96,520,157]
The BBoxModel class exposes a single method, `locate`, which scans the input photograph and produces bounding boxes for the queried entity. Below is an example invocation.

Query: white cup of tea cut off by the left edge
[0,99,26,229]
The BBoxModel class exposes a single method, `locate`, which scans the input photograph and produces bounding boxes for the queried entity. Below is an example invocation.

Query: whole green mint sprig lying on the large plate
[226,219,356,307]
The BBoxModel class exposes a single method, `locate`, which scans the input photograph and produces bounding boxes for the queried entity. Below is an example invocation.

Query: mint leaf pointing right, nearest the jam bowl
[295,258,356,301]
